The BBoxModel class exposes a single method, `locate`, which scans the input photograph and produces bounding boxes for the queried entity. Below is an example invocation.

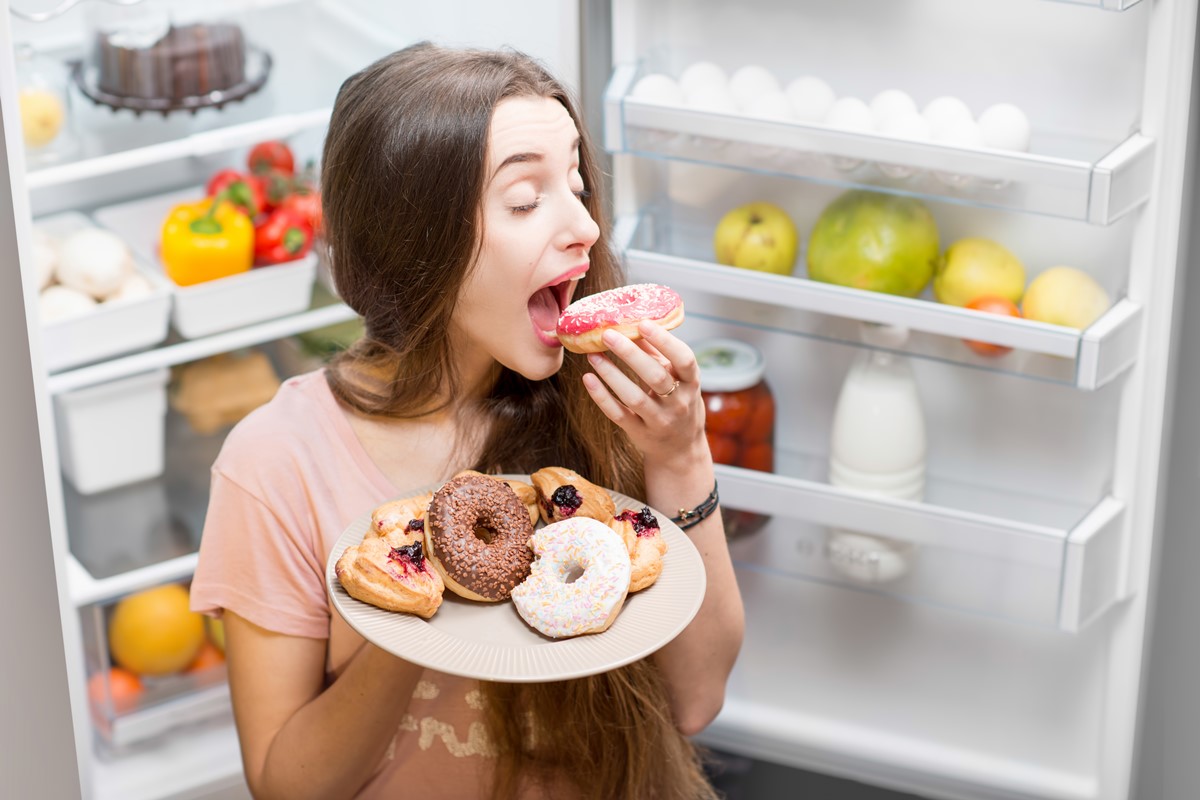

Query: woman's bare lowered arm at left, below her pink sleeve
[224,610,421,800]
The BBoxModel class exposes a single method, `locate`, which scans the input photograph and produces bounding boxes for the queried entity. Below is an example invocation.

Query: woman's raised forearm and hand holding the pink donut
[583,323,745,735]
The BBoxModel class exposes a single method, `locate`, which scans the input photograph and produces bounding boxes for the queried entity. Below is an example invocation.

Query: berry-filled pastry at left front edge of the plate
[334,531,445,619]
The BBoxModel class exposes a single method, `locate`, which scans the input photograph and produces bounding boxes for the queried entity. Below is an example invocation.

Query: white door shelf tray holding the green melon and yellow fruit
[613,213,1141,390]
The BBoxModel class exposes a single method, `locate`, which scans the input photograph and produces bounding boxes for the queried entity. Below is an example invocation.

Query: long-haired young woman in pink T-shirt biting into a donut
[192,44,743,800]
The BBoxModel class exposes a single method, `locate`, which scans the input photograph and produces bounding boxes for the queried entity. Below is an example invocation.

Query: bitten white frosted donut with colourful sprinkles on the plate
[511,517,630,639]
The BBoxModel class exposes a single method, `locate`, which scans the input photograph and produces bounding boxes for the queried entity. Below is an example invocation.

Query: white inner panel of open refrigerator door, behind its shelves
[606,0,1194,800]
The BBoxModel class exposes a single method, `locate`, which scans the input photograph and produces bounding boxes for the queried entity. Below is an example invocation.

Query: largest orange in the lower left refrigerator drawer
[108,583,204,675]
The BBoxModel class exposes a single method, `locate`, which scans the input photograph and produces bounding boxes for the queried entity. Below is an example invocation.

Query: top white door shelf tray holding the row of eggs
[604,65,1154,224]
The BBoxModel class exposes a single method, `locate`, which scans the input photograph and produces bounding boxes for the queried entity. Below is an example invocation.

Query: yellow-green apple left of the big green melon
[713,203,799,275]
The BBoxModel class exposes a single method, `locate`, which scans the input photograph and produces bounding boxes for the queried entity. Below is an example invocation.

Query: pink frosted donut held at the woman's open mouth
[556,283,683,353]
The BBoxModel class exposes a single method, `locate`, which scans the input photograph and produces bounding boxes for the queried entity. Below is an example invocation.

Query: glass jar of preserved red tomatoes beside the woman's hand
[694,338,775,539]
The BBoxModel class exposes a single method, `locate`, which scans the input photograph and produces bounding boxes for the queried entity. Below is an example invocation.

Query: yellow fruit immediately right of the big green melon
[934,236,1025,306]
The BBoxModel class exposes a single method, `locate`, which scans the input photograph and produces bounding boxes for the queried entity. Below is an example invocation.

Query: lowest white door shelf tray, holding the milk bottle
[716,451,1124,632]
